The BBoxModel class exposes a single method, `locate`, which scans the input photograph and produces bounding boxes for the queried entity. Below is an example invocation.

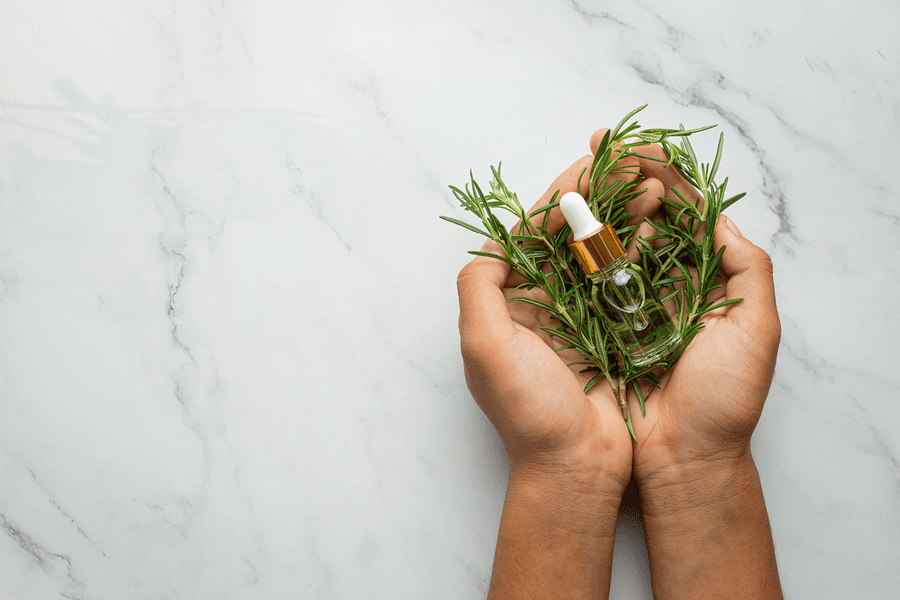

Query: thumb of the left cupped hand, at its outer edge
[456,240,516,356]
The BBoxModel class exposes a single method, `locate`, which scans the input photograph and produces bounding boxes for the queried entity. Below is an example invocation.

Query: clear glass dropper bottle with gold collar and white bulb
[559,192,681,367]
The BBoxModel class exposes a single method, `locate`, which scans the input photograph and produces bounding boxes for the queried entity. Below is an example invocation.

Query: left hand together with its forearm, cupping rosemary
[457,150,652,600]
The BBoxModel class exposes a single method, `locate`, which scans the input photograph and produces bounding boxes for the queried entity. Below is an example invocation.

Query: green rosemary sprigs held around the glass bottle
[441,105,744,439]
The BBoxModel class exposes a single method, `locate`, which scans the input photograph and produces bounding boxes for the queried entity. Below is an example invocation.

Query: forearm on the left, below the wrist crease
[488,466,624,600]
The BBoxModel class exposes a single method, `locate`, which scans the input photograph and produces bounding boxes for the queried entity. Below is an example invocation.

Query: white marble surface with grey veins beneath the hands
[0,0,900,600]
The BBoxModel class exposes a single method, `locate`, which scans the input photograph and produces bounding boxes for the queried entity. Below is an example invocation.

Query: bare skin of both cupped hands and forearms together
[457,130,781,600]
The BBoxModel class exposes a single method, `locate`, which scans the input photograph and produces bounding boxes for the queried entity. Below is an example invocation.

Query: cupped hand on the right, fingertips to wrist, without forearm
[592,130,781,484]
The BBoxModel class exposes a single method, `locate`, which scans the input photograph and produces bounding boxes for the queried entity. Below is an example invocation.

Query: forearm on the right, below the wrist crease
[638,453,782,600]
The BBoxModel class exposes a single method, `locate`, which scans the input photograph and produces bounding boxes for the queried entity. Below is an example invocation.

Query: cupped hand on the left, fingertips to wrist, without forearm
[457,156,648,489]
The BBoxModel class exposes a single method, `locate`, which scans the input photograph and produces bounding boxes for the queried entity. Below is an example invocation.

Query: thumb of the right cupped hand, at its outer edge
[713,215,781,347]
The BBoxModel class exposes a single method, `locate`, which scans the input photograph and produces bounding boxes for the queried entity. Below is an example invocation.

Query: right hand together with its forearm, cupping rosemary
[592,131,782,600]
